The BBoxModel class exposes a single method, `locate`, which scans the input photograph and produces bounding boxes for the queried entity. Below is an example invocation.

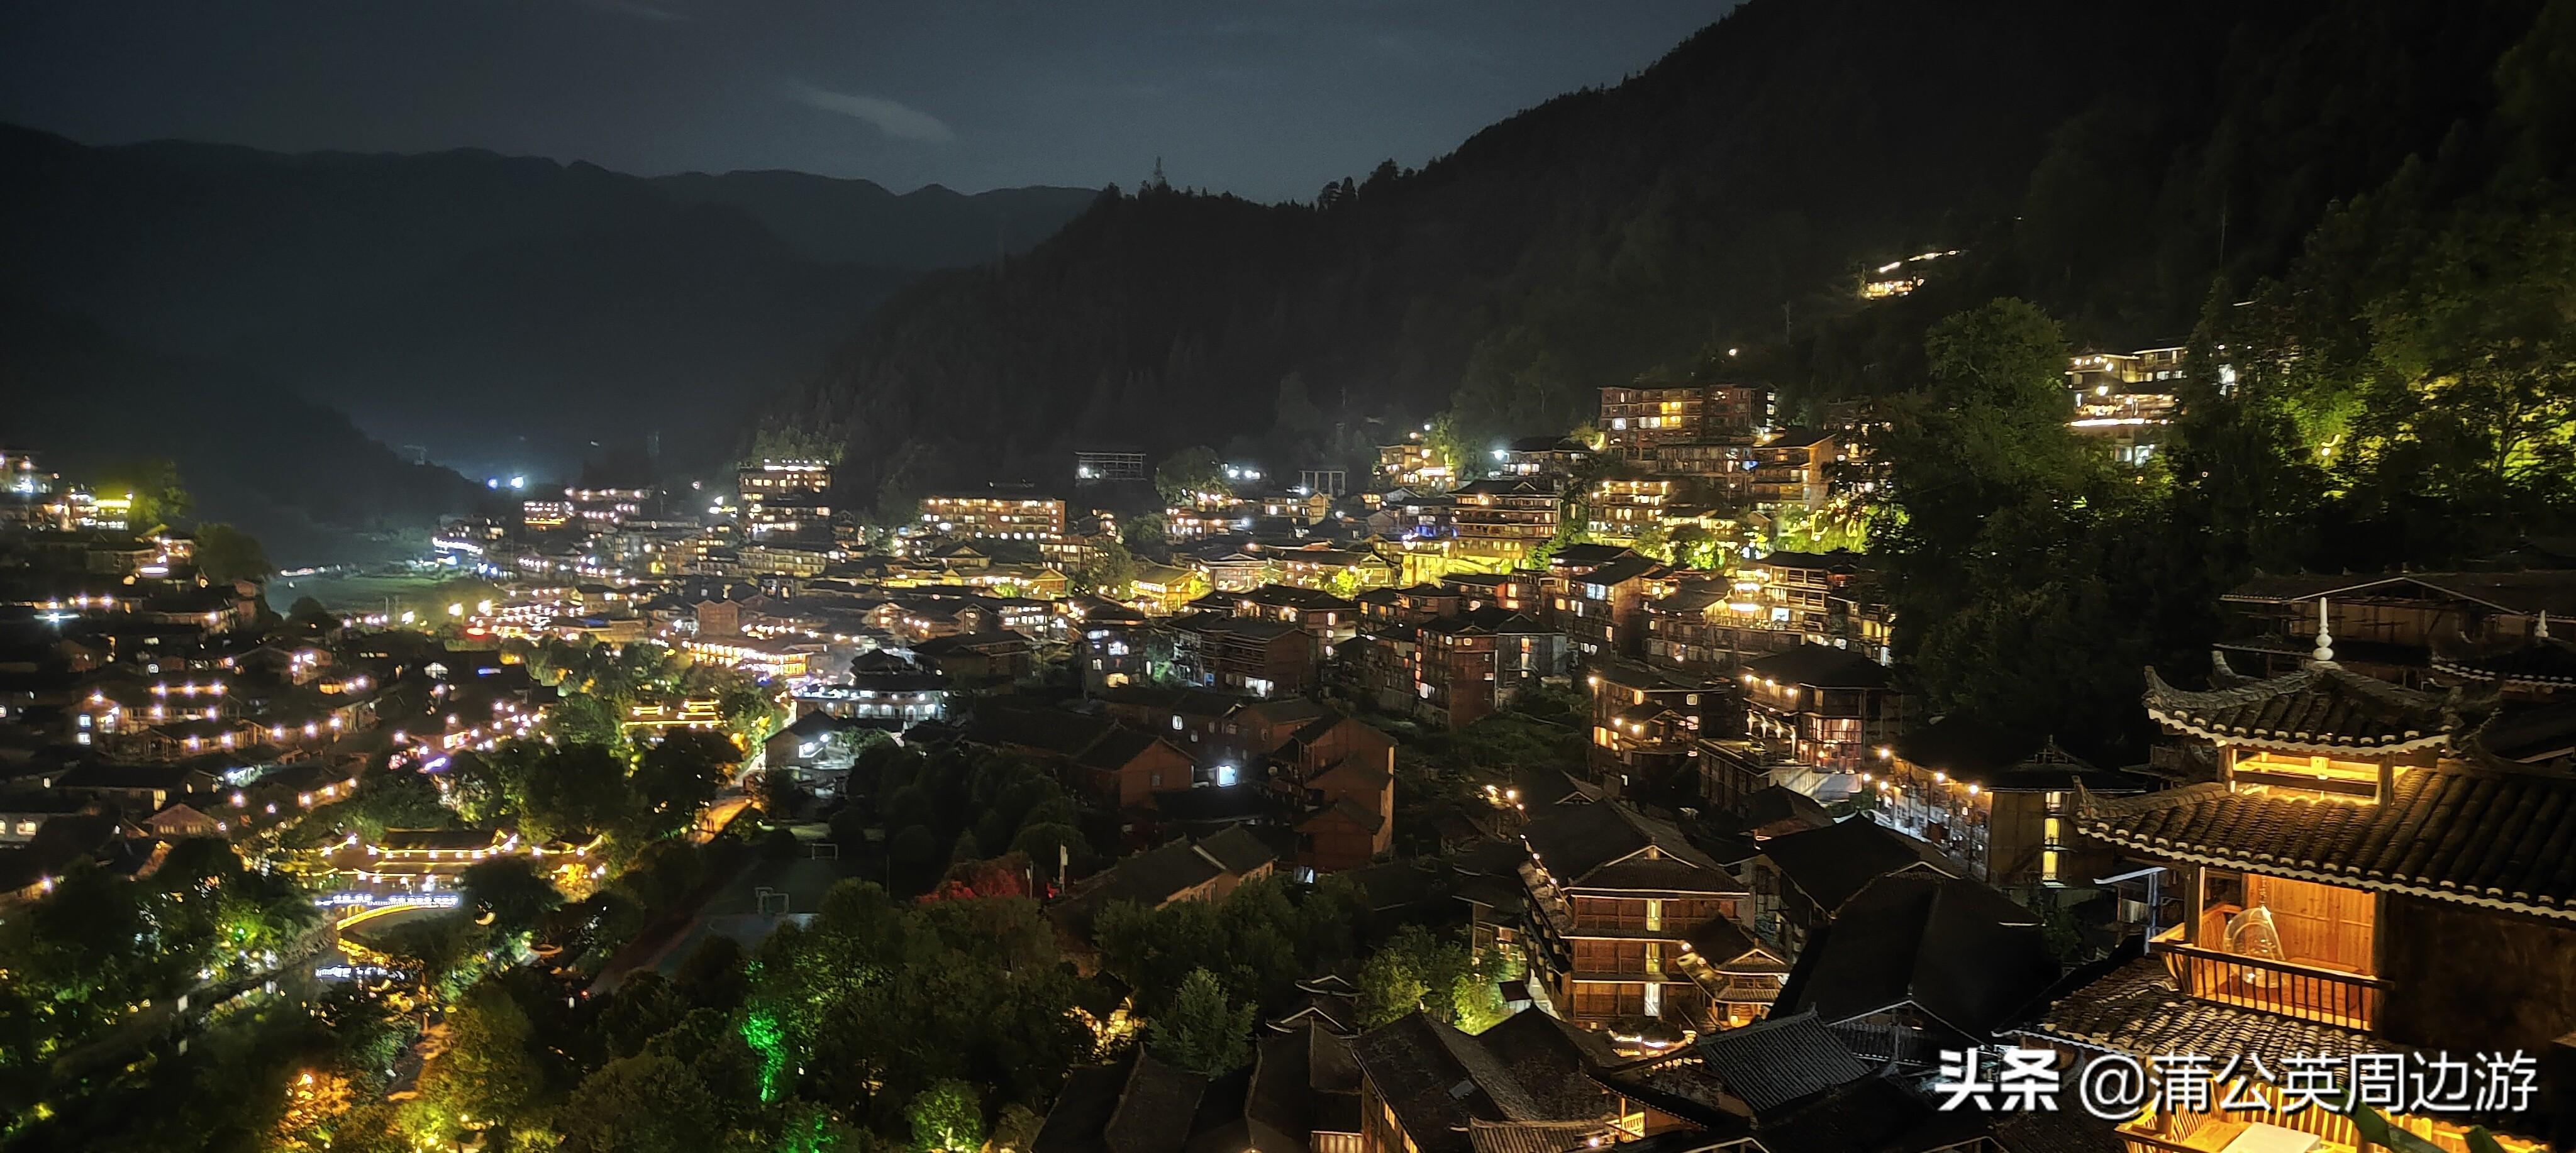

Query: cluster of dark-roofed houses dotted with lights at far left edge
[0,450,579,906]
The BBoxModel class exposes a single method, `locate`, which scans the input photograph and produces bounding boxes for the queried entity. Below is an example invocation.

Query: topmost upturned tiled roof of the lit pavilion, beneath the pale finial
[2146,659,2494,751]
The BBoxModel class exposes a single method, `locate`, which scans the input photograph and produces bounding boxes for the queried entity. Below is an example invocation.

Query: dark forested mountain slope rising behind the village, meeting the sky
[773,0,2529,504]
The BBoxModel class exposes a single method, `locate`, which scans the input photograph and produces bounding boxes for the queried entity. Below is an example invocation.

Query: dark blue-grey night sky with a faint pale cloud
[0,0,1731,198]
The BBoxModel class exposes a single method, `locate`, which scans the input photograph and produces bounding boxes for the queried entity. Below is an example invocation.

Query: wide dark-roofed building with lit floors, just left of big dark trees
[1739,643,1911,772]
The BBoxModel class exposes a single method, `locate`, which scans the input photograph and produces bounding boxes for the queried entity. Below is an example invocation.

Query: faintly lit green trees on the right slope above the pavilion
[1806,0,2576,757]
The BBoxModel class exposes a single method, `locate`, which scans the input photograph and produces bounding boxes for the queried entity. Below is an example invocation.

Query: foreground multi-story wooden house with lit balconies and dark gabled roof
[1523,800,1746,1032]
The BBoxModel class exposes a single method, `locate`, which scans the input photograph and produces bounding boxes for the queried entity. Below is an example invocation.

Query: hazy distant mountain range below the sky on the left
[0,126,1095,481]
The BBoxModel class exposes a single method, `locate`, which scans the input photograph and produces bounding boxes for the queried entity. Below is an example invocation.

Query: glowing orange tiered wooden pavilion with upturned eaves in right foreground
[2030,649,2576,1150]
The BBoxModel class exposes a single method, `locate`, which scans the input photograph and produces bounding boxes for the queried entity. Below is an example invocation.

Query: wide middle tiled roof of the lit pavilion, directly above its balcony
[2076,762,2576,919]
